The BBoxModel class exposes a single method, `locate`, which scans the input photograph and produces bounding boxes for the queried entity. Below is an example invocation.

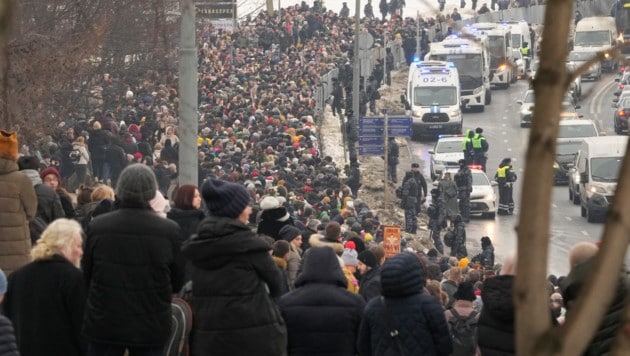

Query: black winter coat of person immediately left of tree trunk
[477,276,516,356]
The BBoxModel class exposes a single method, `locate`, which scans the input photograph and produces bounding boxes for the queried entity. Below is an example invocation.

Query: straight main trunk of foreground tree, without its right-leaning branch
[514,0,573,356]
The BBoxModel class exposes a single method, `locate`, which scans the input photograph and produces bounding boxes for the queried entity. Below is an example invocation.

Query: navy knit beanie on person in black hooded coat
[201,179,250,219]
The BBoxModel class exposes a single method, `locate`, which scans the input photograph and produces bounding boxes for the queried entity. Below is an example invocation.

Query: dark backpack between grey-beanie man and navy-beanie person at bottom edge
[164,297,193,356]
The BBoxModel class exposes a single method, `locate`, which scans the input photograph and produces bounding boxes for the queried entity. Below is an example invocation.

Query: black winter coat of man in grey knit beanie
[82,206,182,347]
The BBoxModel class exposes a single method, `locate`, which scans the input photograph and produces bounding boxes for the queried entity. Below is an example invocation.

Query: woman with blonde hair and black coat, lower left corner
[4,218,87,356]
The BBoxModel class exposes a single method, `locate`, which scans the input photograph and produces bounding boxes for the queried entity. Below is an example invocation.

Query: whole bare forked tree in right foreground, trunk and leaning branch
[514,0,630,356]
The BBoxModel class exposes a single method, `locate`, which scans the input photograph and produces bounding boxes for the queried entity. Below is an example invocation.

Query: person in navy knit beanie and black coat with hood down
[182,179,287,356]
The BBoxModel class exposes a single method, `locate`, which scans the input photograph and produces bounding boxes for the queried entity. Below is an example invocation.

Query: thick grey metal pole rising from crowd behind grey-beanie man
[178,0,199,188]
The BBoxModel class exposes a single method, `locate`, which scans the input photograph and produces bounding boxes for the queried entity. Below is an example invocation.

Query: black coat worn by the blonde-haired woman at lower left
[4,255,87,356]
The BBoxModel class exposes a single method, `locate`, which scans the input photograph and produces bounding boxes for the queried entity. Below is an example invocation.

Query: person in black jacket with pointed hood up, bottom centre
[278,246,365,356]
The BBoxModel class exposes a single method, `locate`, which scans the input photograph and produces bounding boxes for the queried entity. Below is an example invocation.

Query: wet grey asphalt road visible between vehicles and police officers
[411,74,630,275]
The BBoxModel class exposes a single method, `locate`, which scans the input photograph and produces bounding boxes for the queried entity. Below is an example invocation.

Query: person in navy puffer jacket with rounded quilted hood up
[357,252,453,356]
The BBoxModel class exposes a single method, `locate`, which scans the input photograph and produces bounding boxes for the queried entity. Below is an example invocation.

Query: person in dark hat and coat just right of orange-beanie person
[17,156,66,243]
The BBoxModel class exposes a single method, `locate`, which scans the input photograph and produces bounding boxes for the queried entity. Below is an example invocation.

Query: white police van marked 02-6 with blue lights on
[404,61,463,137]
